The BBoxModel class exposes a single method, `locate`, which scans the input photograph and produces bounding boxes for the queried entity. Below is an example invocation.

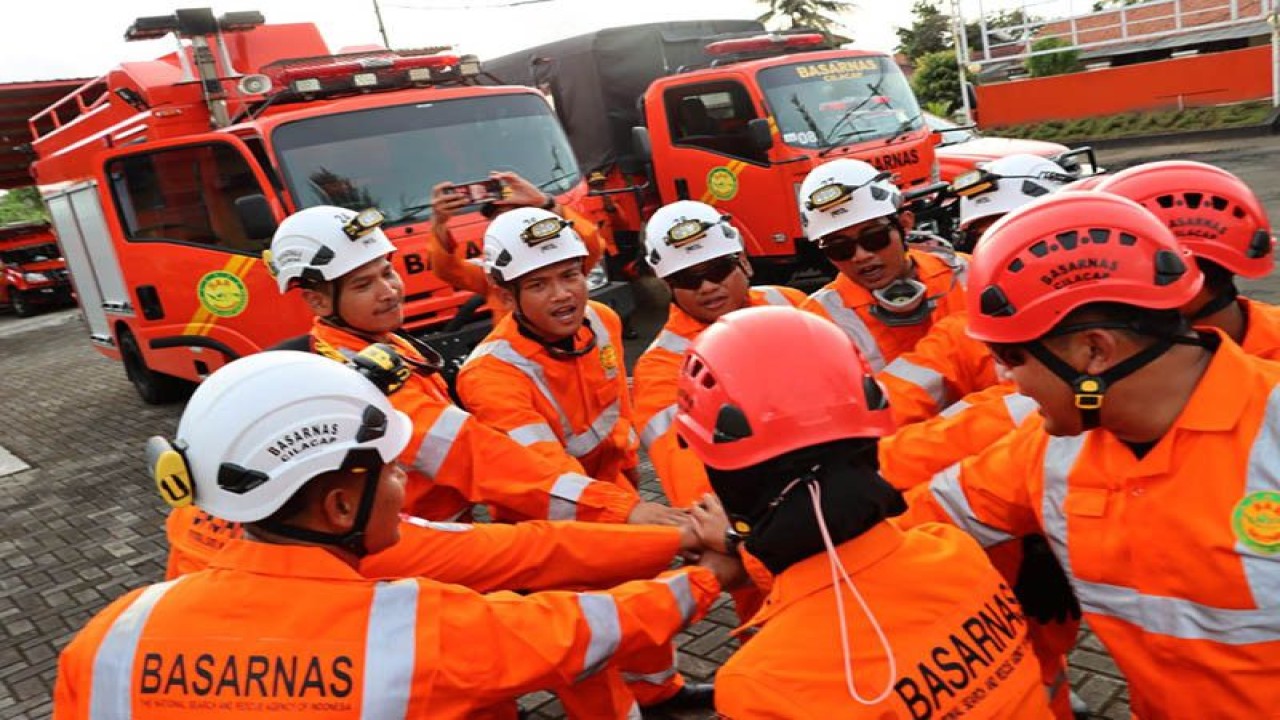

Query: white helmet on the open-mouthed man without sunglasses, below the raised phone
[484,208,586,282]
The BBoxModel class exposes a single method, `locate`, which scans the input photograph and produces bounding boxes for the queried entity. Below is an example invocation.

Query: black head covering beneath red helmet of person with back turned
[707,441,906,574]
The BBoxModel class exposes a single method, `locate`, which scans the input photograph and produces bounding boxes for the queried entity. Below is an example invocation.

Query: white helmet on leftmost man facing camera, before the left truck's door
[262,205,396,292]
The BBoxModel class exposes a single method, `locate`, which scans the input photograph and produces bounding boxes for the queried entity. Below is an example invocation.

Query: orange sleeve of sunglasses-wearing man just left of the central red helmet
[635,348,712,507]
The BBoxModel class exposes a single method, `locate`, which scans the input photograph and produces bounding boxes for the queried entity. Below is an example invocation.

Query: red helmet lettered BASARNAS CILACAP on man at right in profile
[968,192,1204,342]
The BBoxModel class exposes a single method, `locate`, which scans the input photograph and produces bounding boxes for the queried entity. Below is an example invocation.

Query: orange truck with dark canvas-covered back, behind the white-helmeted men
[484,20,940,281]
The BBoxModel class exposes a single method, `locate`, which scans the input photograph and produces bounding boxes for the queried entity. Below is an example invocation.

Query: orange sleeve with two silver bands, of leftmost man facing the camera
[390,387,640,523]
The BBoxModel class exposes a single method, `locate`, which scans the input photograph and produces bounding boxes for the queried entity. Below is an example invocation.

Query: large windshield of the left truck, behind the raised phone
[280,94,580,224]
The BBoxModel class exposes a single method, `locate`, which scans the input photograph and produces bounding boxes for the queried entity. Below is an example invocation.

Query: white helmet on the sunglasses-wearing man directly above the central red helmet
[644,200,742,278]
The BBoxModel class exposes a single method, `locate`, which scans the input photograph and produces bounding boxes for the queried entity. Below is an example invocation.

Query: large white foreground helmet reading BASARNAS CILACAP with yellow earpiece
[147,350,413,523]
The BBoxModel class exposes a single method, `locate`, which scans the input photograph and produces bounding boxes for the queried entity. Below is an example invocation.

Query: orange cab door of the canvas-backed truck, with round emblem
[646,78,795,259]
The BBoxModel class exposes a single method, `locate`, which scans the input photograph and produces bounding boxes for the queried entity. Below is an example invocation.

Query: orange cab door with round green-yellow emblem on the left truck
[102,133,302,379]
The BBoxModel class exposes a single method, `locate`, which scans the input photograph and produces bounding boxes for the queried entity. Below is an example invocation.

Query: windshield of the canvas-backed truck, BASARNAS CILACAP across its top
[758,55,923,149]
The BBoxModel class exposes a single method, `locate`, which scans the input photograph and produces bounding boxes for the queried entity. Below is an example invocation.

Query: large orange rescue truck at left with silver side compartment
[29,9,631,402]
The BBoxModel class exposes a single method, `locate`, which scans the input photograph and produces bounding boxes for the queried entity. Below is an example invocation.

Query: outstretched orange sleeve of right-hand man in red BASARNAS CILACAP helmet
[896,423,1047,547]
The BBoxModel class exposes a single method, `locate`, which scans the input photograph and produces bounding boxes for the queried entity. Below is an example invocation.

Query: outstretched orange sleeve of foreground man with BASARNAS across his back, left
[432,568,721,702]
